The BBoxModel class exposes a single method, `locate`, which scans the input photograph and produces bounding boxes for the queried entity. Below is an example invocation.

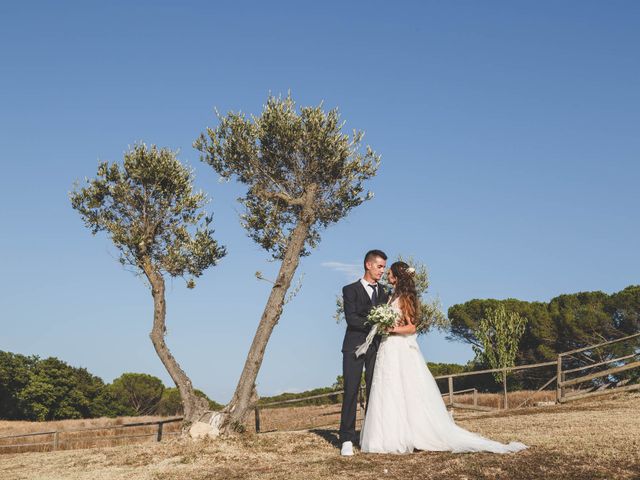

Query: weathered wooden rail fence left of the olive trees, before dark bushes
[0,417,183,454]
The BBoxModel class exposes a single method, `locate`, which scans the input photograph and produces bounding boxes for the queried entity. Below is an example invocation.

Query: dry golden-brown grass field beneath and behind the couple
[0,394,640,480]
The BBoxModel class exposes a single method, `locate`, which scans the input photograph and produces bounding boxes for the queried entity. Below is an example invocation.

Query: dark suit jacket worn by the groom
[342,280,389,352]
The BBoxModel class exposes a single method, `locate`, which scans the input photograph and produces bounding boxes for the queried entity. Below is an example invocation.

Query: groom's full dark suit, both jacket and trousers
[340,280,388,443]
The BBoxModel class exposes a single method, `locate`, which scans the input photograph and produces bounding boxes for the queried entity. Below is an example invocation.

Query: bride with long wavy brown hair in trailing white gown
[360,262,527,453]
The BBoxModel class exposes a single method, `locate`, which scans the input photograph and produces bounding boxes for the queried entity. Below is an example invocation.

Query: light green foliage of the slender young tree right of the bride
[473,305,527,381]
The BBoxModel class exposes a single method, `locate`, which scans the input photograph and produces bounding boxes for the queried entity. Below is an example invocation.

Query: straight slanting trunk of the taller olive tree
[220,186,316,434]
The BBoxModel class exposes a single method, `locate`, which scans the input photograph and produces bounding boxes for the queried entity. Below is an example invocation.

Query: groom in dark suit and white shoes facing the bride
[340,250,389,456]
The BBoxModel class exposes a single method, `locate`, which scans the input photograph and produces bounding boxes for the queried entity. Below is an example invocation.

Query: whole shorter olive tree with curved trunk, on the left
[70,144,226,425]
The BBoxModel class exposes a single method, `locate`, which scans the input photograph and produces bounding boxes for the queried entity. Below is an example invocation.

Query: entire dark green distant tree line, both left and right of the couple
[0,286,640,420]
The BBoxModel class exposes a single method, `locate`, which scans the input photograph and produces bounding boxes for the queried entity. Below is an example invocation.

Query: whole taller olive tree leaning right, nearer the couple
[194,95,380,433]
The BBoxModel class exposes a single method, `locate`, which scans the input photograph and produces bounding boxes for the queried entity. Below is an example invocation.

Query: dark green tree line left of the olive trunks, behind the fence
[0,351,222,421]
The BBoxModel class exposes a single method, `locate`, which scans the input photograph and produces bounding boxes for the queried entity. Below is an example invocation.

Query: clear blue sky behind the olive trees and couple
[0,1,640,401]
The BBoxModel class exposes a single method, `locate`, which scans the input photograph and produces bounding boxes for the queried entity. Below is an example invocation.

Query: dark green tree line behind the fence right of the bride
[439,285,640,391]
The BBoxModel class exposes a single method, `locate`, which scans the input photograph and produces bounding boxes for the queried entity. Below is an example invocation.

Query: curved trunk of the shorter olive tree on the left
[143,261,209,432]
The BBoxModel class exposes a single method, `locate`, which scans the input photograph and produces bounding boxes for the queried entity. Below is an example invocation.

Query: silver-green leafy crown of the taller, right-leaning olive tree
[194,95,380,259]
